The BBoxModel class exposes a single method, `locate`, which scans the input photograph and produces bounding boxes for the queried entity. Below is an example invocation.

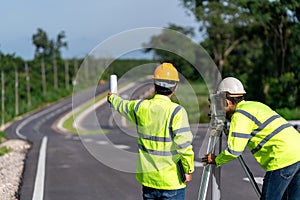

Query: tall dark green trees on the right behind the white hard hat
[146,0,300,118]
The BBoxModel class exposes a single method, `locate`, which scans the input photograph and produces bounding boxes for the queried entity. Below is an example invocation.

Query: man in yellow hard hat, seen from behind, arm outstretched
[108,63,194,199]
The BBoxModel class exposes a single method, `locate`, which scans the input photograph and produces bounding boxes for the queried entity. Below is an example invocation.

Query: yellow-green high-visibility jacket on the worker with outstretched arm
[109,94,194,190]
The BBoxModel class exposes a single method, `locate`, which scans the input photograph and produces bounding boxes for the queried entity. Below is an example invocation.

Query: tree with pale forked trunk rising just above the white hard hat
[182,0,250,74]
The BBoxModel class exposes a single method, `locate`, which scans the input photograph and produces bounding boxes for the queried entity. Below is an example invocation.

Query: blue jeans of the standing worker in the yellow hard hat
[143,186,185,200]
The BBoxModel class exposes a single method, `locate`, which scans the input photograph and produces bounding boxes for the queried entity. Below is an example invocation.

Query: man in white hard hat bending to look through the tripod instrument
[202,77,300,200]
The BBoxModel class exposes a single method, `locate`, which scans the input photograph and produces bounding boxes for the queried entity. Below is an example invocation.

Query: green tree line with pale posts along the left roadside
[0,28,159,125]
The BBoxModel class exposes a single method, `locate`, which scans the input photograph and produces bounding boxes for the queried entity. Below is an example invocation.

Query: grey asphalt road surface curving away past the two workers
[6,82,264,200]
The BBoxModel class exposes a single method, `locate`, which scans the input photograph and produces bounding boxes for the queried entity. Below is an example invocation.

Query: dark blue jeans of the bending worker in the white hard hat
[261,161,300,200]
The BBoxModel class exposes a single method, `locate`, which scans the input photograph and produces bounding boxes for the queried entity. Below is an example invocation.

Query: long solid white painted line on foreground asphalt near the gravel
[32,136,48,200]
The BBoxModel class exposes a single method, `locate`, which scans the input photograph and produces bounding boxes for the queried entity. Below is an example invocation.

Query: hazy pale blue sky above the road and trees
[0,0,202,60]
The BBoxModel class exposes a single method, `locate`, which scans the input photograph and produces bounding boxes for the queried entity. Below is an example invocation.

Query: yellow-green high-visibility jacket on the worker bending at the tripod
[216,101,300,171]
